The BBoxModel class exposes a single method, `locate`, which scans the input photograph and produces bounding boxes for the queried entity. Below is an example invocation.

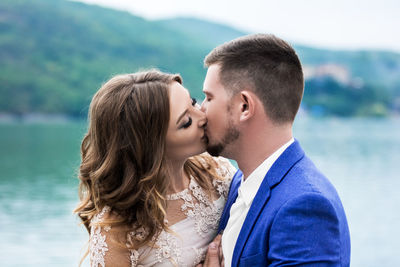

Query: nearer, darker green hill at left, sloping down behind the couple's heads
[0,0,208,116]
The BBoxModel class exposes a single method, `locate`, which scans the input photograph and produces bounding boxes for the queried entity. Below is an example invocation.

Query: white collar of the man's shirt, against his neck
[238,138,294,206]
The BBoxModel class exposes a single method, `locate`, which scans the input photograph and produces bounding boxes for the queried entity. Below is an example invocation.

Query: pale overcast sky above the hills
[74,0,400,52]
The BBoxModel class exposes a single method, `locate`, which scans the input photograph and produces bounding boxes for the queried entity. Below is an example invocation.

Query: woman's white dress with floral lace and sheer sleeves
[89,161,236,267]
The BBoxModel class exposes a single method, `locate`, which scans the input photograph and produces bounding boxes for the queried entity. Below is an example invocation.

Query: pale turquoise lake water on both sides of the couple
[0,118,400,267]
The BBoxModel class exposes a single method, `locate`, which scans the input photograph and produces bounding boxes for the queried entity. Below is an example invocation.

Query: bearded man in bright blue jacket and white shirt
[202,34,350,266]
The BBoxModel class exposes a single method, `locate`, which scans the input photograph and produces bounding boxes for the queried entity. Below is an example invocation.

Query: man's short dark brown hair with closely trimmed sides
[204,34,304,123]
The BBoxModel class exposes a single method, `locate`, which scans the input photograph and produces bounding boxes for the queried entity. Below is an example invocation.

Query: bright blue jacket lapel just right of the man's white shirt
[232,140,304,266]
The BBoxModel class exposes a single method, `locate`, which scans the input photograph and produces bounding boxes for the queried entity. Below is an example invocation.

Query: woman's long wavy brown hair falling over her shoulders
[75,70,217,254]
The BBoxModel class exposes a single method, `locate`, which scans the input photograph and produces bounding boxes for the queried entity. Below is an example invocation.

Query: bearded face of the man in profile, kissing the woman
[201,64,239,157]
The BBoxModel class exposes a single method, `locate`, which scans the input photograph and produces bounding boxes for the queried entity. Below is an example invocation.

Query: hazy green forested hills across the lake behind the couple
[0,0,400,117]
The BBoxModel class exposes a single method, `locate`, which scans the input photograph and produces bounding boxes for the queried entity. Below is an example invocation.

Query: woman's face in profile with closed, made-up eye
[166,82,206,161]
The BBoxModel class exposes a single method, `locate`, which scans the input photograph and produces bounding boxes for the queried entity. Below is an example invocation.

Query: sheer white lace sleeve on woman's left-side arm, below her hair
[89,207,139,267]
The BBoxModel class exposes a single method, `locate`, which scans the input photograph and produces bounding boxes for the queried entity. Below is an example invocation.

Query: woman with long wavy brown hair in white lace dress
[75,71,234,267]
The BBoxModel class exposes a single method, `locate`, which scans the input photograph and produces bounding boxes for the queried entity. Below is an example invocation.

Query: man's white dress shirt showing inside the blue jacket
[222,138,294,267]
